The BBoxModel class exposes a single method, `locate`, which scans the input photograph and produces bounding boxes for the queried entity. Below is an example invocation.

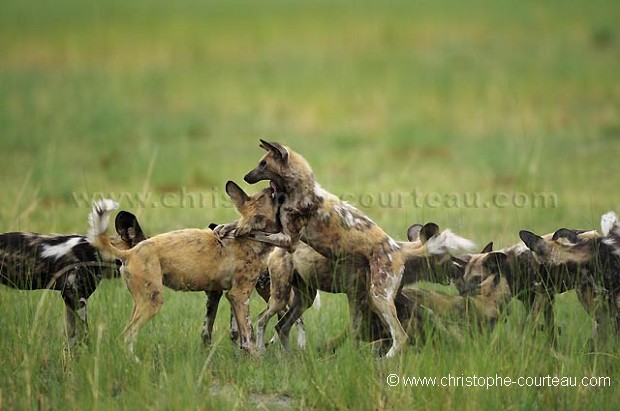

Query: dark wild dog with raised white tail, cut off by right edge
[526,219,620,344]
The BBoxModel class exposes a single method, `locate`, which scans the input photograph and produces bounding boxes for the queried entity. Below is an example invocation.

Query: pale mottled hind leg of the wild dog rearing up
[369,258,409,358]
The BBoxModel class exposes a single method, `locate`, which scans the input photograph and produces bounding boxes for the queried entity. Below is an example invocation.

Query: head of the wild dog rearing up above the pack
[243,140,314,194]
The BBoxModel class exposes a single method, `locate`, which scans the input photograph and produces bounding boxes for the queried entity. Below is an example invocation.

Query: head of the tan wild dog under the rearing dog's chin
[226,181,282,233]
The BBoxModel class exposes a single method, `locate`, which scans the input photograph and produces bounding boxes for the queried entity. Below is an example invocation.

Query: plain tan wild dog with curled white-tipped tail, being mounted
[89,181,280,354]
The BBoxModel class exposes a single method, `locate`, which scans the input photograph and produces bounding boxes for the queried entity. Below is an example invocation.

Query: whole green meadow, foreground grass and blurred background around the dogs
[0,0,620,410]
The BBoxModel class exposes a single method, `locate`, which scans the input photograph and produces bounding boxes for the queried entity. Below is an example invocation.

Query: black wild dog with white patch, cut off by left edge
[0,211,144,348]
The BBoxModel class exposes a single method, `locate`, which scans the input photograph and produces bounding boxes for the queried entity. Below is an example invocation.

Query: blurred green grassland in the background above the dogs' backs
[0,0,620,244]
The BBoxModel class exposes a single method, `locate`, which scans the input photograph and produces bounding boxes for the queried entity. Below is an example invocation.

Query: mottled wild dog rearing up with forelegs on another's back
[219,140,474,357]
